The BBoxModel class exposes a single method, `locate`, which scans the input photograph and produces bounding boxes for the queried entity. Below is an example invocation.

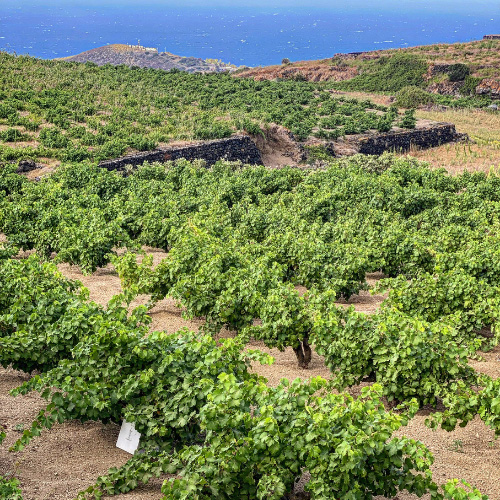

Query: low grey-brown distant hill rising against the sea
[58,43,236,73]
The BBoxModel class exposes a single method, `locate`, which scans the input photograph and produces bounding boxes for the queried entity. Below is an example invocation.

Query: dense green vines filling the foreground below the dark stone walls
[0,154,500,500]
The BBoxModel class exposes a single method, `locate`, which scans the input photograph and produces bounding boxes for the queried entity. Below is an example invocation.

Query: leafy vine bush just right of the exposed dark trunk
[311,305,477,404]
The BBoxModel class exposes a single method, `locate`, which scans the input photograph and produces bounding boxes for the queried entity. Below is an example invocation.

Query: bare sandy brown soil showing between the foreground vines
[0,254,500,500]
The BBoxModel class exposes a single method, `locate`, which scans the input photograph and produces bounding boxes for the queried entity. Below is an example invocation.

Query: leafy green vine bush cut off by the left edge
[0,256,94,372]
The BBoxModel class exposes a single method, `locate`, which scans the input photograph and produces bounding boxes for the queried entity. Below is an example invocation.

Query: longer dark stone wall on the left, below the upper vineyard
[99,135,262,170]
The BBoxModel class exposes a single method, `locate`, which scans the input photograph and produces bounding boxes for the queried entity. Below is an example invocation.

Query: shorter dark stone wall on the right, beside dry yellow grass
[342,123,466,155]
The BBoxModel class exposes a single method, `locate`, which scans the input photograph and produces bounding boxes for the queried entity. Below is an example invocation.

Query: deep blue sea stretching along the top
[0,0,500,66]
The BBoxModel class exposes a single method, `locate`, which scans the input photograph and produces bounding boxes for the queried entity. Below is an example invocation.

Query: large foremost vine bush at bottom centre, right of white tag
[162,374,436,500]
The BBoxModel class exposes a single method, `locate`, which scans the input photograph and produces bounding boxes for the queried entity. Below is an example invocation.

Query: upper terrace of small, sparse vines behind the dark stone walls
[0,52,422,166]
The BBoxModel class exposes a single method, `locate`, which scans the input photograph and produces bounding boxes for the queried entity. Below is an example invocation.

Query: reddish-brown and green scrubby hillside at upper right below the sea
[238,40,500,98]
